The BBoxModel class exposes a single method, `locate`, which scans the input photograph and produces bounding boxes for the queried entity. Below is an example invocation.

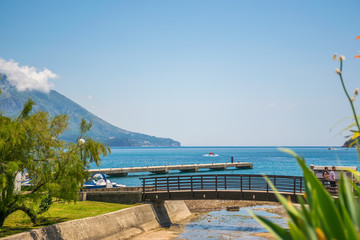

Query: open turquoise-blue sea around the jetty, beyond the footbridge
[91,147,359,186]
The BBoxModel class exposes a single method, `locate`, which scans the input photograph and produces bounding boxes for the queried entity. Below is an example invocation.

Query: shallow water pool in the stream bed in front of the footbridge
[177,205,287,240]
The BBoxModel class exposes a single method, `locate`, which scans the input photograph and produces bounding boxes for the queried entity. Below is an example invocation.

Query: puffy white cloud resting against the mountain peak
[0,58,58,93]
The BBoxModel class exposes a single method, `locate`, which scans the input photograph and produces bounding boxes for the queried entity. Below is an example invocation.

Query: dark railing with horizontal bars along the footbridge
[140,174,304,194]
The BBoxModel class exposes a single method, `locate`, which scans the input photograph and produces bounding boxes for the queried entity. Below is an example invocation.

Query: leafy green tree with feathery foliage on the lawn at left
[0,86,110,227]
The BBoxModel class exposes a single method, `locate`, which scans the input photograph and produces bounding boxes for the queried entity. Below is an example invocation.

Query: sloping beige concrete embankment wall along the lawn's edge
[2,201,190,240]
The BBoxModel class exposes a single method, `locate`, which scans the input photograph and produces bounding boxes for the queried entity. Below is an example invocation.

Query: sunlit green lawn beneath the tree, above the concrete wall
[0,201,134,238]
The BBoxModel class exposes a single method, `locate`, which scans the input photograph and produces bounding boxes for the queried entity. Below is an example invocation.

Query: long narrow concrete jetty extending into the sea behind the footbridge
[89,162,253,177]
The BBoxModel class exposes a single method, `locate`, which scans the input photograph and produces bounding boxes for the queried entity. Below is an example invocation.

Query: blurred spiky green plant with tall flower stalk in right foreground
[252,40,360,240]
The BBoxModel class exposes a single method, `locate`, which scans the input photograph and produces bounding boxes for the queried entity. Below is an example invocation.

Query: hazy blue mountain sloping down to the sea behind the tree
[0,75,180,147]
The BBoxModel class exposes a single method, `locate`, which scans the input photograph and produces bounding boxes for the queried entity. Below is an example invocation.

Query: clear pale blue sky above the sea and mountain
[0,0,360,146]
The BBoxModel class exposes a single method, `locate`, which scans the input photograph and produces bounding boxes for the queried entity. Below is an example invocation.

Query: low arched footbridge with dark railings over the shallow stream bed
[141,174,304,202]
